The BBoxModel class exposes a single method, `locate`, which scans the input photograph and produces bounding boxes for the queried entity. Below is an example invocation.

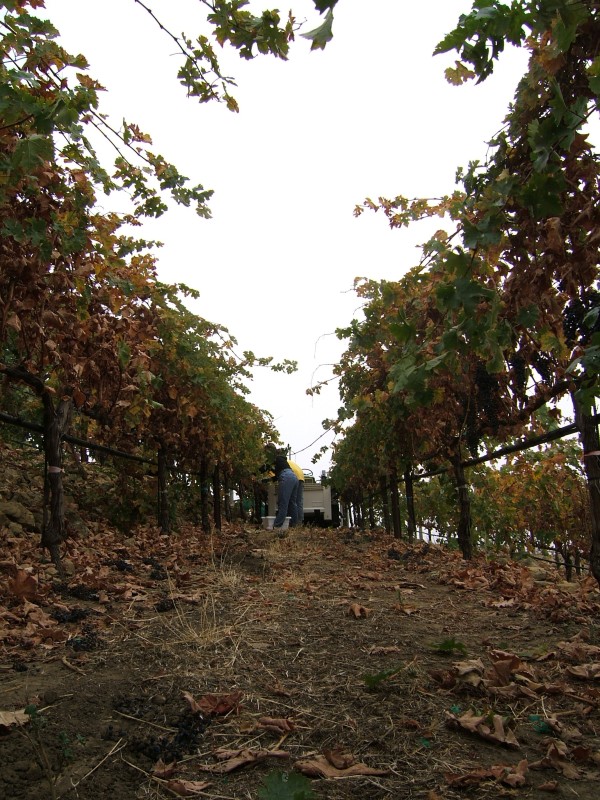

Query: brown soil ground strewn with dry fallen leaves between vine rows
[0,526,600,800]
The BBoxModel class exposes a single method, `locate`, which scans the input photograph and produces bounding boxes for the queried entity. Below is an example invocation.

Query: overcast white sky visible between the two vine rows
[40,0,526,474]
